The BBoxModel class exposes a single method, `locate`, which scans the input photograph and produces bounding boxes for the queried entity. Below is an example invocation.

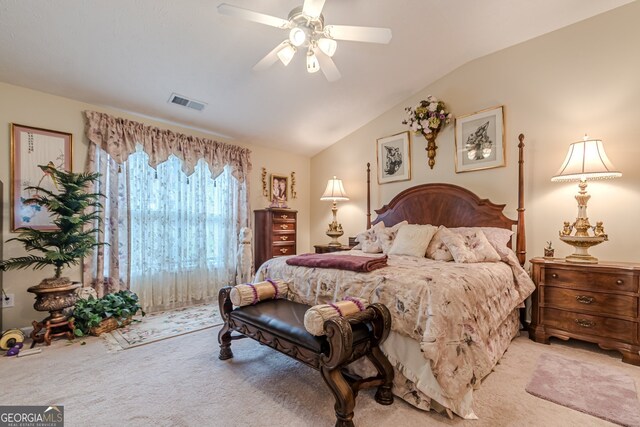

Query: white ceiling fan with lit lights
[218,0,391,82]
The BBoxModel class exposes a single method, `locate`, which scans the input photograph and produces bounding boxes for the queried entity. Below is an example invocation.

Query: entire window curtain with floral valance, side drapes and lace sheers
[83,112,251,311]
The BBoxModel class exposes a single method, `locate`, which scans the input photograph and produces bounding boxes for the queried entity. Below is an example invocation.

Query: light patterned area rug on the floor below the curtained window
[104,304,222,350]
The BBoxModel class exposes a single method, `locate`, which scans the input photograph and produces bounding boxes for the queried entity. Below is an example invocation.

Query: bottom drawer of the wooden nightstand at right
[543,308,637,342]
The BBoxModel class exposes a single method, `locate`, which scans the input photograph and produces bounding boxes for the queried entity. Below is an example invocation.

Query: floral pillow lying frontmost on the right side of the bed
[442,229,500,263]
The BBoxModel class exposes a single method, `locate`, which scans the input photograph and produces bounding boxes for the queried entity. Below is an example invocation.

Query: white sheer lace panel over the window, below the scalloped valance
[126,150,246,312]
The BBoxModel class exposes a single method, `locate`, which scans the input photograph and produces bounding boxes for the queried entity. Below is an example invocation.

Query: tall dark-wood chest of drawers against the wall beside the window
[254,208,298,270]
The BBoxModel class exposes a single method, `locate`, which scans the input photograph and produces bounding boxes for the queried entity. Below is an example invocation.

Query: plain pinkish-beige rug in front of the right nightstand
[526,353,640,427]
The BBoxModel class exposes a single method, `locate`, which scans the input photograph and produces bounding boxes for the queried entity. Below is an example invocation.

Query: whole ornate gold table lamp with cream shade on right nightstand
[551,135,622,264]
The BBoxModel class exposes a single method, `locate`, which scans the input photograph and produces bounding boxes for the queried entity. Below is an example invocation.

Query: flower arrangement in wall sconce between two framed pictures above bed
[402,95,452,169]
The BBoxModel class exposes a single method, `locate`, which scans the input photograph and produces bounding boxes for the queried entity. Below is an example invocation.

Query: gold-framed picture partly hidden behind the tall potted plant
[11,123,72,231]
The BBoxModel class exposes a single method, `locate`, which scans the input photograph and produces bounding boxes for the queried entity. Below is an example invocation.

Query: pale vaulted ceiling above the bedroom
[0,0,630,155]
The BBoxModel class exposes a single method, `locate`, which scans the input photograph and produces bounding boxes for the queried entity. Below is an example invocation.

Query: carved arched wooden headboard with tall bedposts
[367,134,526,264]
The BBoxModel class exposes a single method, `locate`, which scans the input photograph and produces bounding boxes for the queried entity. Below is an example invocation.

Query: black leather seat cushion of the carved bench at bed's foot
[229,299,370,354]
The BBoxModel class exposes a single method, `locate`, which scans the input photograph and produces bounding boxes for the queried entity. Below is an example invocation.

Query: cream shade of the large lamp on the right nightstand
[551,136,622,182]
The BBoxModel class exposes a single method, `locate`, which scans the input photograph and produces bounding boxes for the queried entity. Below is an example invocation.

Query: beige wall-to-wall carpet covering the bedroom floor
[0,327,640,427]
